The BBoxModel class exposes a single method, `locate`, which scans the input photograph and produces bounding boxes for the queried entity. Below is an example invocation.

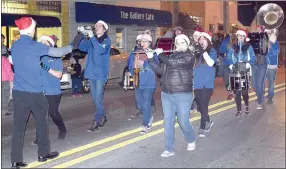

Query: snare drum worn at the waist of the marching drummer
[229,72,250,90]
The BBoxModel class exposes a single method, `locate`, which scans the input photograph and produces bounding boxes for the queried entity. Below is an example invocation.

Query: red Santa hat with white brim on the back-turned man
[15,17,36,35]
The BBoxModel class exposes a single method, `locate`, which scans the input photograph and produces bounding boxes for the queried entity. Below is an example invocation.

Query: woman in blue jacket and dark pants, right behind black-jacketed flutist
[194,32,217,137]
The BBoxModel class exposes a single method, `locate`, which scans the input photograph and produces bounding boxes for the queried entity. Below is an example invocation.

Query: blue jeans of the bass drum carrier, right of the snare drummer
[252,64,267,104]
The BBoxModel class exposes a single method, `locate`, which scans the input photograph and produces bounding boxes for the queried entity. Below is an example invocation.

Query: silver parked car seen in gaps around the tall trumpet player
[61,47,128,93]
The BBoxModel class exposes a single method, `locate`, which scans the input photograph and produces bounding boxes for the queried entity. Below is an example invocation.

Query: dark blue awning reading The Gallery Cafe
[75,2,172,27]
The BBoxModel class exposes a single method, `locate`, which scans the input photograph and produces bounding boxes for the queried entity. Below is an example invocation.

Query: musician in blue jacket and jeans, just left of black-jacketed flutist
[128,33,159,134]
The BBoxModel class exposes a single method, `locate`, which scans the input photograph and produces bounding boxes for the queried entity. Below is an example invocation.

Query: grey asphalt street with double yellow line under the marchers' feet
[1,69,285,168]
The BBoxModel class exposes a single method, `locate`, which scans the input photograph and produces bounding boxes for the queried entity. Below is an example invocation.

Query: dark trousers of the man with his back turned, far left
[11,90,51,162]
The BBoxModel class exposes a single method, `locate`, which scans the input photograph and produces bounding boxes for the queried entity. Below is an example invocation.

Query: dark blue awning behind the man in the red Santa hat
[1,13,61,27]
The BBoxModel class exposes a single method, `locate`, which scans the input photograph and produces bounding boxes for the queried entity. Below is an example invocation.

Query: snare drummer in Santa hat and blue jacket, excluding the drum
[227,30,256,117]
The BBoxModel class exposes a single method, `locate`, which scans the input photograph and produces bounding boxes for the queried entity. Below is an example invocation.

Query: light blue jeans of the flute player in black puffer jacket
[161,91,196,152]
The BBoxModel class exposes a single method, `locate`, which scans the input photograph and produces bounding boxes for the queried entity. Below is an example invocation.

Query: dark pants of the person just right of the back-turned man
[46,94,67,132]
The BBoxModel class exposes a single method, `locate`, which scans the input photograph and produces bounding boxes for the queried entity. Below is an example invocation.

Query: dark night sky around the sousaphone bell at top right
[238,1,286,26]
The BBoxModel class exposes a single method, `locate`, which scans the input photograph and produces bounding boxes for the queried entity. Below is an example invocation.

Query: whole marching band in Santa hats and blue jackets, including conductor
[2,17,279,167]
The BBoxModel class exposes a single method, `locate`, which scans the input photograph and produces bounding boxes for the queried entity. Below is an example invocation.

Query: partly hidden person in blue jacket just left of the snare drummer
[219,34,233,100]
